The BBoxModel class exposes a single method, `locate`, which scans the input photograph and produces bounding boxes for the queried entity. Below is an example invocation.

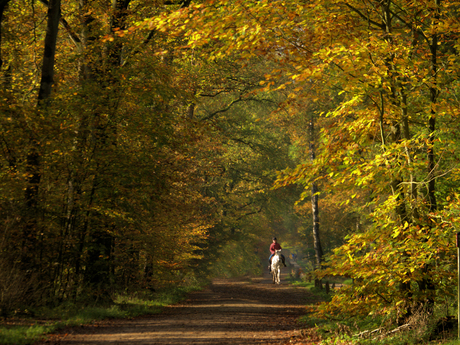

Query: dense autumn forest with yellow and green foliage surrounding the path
[0,0,460,328]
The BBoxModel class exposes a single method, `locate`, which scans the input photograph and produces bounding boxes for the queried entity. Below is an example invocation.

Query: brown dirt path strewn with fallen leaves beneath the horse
[38,270,315,345]
